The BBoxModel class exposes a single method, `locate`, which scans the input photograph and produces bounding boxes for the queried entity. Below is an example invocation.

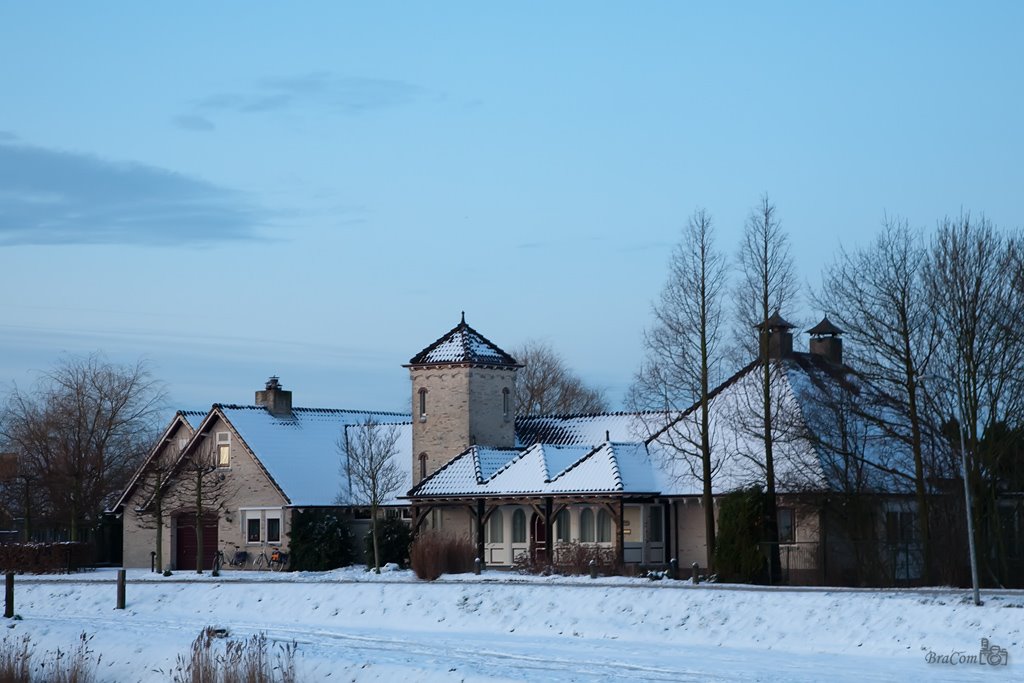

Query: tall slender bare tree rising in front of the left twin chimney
[735,195,797,578]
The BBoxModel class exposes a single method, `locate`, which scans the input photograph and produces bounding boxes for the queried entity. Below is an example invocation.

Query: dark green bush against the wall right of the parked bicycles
[288,508,352,571]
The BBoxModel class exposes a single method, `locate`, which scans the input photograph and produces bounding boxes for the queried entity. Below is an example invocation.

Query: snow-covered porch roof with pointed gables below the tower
[410,442,659,498]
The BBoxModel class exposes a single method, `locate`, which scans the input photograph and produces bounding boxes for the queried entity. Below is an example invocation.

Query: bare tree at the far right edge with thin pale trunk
[928,214,1024,577]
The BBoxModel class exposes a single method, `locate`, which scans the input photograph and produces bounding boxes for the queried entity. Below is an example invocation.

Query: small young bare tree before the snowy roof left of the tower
[338,418,406,573]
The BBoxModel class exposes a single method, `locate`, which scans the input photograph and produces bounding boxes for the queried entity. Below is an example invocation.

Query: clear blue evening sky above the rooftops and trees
[0,2,1024,410]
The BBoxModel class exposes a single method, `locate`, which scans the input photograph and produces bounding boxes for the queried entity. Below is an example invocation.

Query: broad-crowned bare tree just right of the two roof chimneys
[816,217,938,583]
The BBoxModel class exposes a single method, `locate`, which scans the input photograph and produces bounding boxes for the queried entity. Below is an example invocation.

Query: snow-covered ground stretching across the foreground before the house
[5,569,1024,683]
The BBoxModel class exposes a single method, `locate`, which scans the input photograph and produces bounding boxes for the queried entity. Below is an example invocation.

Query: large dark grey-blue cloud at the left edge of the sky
[0,142,261,247]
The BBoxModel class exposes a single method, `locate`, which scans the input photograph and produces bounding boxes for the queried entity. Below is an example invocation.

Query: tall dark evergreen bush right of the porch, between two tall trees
[715,486,767,584]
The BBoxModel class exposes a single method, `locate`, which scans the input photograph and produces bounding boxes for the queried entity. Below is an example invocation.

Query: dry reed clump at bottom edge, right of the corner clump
[173,627,297,683]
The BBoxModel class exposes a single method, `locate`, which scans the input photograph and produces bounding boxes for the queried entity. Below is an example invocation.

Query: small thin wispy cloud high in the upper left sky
[196,72,424,114]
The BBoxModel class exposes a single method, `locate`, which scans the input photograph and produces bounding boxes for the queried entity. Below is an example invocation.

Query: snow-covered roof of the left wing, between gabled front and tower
[215,405,412,506]
